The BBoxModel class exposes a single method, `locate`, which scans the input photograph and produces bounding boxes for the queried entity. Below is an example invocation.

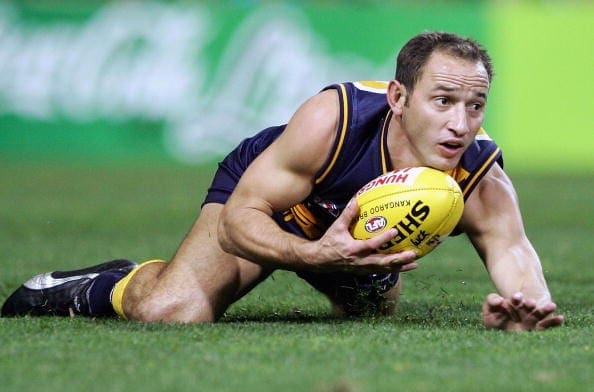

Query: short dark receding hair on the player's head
[395,31,494,91]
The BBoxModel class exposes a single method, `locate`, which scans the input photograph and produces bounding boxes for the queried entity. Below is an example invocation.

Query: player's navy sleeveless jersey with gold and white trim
[204,81,503,239]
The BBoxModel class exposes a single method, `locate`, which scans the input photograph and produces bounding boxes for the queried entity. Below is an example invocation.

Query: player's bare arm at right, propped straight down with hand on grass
[461,165,563,330]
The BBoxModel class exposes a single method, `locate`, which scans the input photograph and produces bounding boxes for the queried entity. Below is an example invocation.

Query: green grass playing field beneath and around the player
[0,159,594,392]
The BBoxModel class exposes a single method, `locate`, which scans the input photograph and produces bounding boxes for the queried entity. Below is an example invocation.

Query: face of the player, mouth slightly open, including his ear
[389,52,489,170]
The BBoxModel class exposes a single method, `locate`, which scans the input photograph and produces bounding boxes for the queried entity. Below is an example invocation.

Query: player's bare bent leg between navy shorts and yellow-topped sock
[131,203,271,322]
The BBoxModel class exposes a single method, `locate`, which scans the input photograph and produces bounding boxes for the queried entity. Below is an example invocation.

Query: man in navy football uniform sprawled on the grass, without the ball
[2,32,563,331]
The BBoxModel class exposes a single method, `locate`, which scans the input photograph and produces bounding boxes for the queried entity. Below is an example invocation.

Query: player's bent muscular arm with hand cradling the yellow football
[218,91,416,272]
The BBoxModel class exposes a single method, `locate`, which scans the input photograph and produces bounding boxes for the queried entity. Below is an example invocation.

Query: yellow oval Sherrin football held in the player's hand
[351,167,464,257]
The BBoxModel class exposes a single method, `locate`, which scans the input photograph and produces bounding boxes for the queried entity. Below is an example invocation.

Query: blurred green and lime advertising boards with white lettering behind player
[0,1,594,170]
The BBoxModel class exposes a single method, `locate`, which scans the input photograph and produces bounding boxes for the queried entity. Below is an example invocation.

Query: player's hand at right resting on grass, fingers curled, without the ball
[483,292,564,331]
